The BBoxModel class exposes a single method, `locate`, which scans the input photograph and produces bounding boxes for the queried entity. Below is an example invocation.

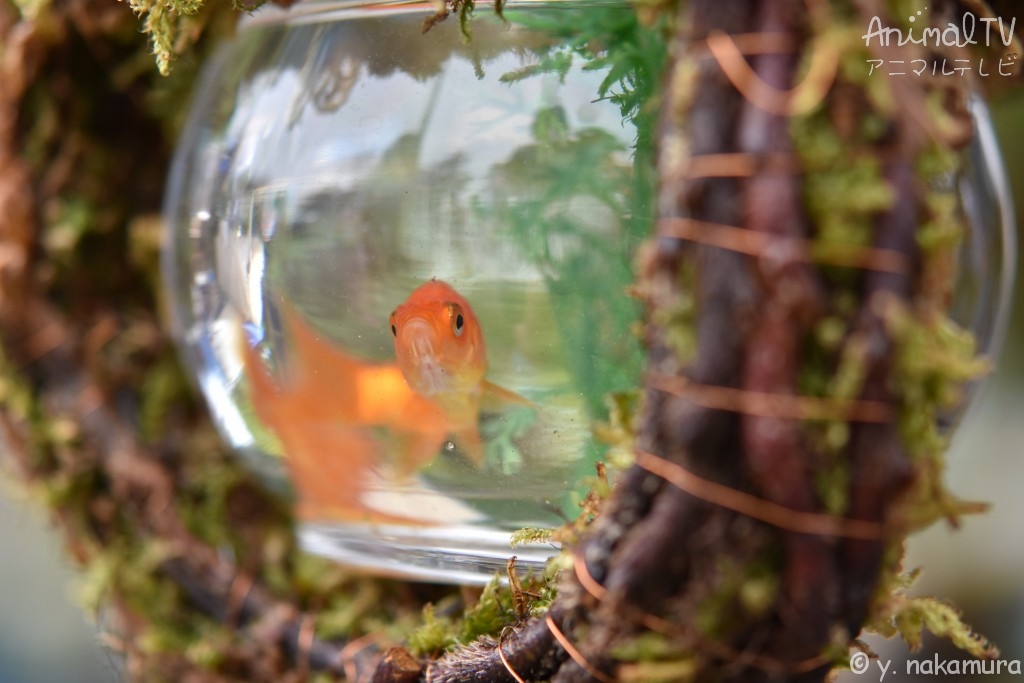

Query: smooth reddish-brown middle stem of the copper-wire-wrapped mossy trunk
[737,2,839,663]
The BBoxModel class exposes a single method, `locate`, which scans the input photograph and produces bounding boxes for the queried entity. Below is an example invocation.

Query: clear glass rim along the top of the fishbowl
[239,0,631,30]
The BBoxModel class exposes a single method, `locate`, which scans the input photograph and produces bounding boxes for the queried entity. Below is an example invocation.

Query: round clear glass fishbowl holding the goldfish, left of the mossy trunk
[165,2,656,582]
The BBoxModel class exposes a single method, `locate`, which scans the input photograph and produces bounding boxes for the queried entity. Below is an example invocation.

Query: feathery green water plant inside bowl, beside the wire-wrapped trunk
[485,7,666,416]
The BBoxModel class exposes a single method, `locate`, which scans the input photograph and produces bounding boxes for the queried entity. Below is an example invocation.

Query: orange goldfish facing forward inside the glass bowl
[243,280,532,521]
